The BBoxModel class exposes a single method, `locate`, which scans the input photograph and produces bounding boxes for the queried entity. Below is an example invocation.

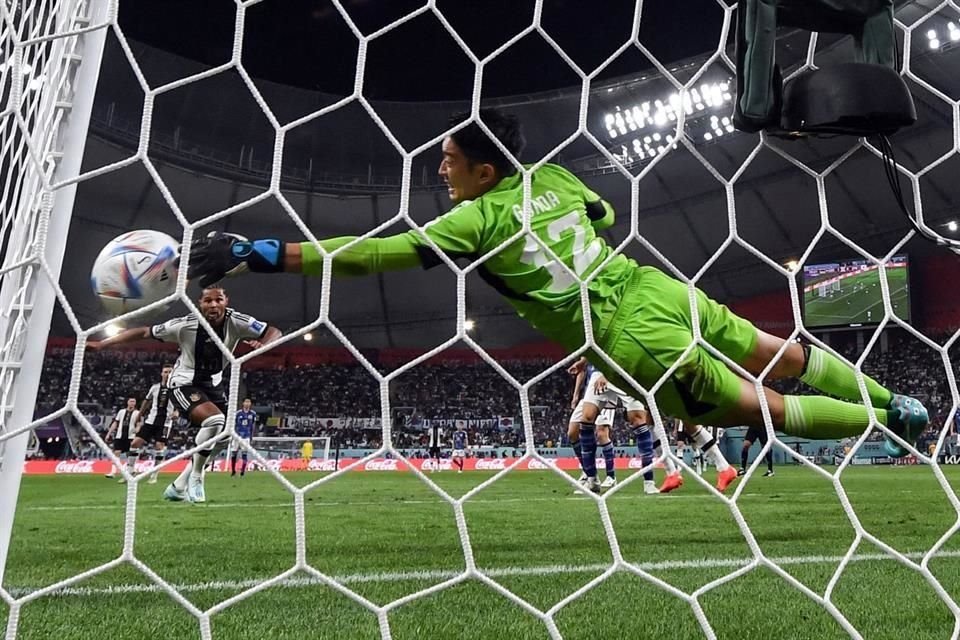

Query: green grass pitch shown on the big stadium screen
[803,269,910,327]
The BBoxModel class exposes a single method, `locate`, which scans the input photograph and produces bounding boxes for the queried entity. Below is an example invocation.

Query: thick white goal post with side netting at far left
[0,0,111,584]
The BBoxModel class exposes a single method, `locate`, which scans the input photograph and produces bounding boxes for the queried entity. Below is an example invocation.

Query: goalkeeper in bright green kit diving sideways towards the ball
[188,109,929,490]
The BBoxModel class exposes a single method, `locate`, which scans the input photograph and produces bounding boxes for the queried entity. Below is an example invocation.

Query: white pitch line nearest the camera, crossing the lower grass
[7,551,960,598]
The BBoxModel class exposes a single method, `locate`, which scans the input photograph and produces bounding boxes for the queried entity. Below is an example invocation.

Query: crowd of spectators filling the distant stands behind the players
[38,331,952,458]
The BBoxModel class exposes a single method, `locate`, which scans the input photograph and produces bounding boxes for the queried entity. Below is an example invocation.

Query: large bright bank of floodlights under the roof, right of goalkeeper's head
[603,79,733,139]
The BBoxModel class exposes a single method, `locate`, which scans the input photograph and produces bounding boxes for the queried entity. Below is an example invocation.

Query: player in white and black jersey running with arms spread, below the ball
[88,285,283,503]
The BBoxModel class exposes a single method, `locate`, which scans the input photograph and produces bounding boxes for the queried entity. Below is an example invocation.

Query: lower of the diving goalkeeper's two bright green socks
[783,396,888,440]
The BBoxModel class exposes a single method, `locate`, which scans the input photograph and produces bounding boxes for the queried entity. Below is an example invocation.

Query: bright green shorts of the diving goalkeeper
[597,267,757,424]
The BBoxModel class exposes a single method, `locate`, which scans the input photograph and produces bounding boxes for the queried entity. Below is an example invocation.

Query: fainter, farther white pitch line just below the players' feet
[20,490,832,511]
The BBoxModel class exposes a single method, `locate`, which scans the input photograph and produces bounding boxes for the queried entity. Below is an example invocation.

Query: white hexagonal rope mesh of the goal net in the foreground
[0,0,960,639]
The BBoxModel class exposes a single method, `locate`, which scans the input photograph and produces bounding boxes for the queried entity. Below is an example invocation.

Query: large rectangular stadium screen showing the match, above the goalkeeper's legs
[803,256,910,328]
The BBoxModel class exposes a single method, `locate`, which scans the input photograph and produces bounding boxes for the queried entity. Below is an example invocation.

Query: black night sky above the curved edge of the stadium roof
[120,0,723,100]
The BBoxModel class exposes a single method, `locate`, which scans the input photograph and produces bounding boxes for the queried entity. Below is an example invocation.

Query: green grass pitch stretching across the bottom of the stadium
[2,467,960,640]
